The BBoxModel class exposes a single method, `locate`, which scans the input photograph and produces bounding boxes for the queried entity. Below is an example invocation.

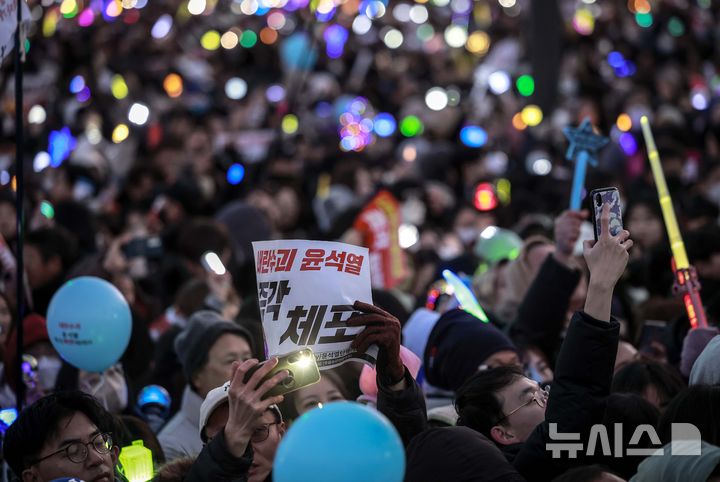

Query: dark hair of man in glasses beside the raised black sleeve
[455,366,524,438]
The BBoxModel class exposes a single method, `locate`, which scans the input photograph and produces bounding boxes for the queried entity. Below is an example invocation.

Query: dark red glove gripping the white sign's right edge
[347,301,405,385]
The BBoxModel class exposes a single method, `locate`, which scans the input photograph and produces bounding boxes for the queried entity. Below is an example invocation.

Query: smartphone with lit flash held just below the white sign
[245,348,320,398]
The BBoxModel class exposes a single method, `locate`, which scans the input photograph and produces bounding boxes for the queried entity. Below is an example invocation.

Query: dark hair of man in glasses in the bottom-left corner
[3,390,113,477]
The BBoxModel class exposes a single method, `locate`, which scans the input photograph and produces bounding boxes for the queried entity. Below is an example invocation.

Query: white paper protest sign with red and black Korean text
[253,240,377,369]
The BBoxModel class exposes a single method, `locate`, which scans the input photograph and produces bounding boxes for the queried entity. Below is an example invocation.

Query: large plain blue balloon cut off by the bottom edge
[273,402,405,482]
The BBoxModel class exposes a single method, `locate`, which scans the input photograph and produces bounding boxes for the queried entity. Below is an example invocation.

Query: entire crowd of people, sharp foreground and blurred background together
[0,0,720,482]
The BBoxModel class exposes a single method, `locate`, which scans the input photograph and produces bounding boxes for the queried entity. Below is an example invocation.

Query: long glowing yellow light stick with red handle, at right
[640,116,707,329]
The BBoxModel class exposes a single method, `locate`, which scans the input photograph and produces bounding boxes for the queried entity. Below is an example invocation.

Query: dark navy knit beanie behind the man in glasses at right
[423,309,517,391]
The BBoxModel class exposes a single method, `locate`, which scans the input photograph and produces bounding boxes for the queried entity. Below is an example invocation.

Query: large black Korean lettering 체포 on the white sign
[280,305,355,346]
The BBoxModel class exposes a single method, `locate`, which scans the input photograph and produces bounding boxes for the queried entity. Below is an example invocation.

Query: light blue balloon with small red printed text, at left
[47,276,132,372]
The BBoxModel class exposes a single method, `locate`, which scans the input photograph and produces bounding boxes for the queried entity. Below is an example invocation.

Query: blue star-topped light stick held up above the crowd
[563,117,608,211]
